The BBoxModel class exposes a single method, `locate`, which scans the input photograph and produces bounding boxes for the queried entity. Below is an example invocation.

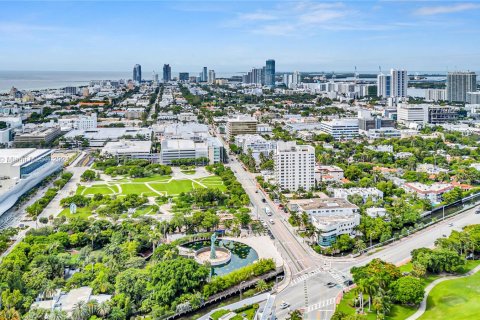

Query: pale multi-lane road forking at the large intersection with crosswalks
[220,136,480,319]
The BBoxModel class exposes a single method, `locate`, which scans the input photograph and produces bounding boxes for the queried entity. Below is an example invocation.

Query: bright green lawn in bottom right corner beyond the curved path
[420,273,480,319]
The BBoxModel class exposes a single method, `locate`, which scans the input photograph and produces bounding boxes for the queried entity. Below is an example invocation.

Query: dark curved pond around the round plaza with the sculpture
[182,239,258,275]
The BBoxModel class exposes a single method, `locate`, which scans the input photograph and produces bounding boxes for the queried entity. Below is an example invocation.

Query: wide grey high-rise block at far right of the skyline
[447,71,477,102]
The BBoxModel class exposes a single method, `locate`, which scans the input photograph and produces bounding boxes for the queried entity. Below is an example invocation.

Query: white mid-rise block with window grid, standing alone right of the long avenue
[274,141,315,191]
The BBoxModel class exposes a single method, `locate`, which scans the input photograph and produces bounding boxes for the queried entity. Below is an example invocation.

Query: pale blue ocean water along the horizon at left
[0,71,132,92]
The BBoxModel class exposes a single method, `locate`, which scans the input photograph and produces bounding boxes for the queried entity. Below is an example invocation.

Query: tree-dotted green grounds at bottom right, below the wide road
[332,225,480,320]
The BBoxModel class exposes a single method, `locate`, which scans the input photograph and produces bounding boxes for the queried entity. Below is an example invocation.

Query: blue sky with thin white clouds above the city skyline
[0,0,480,74]
